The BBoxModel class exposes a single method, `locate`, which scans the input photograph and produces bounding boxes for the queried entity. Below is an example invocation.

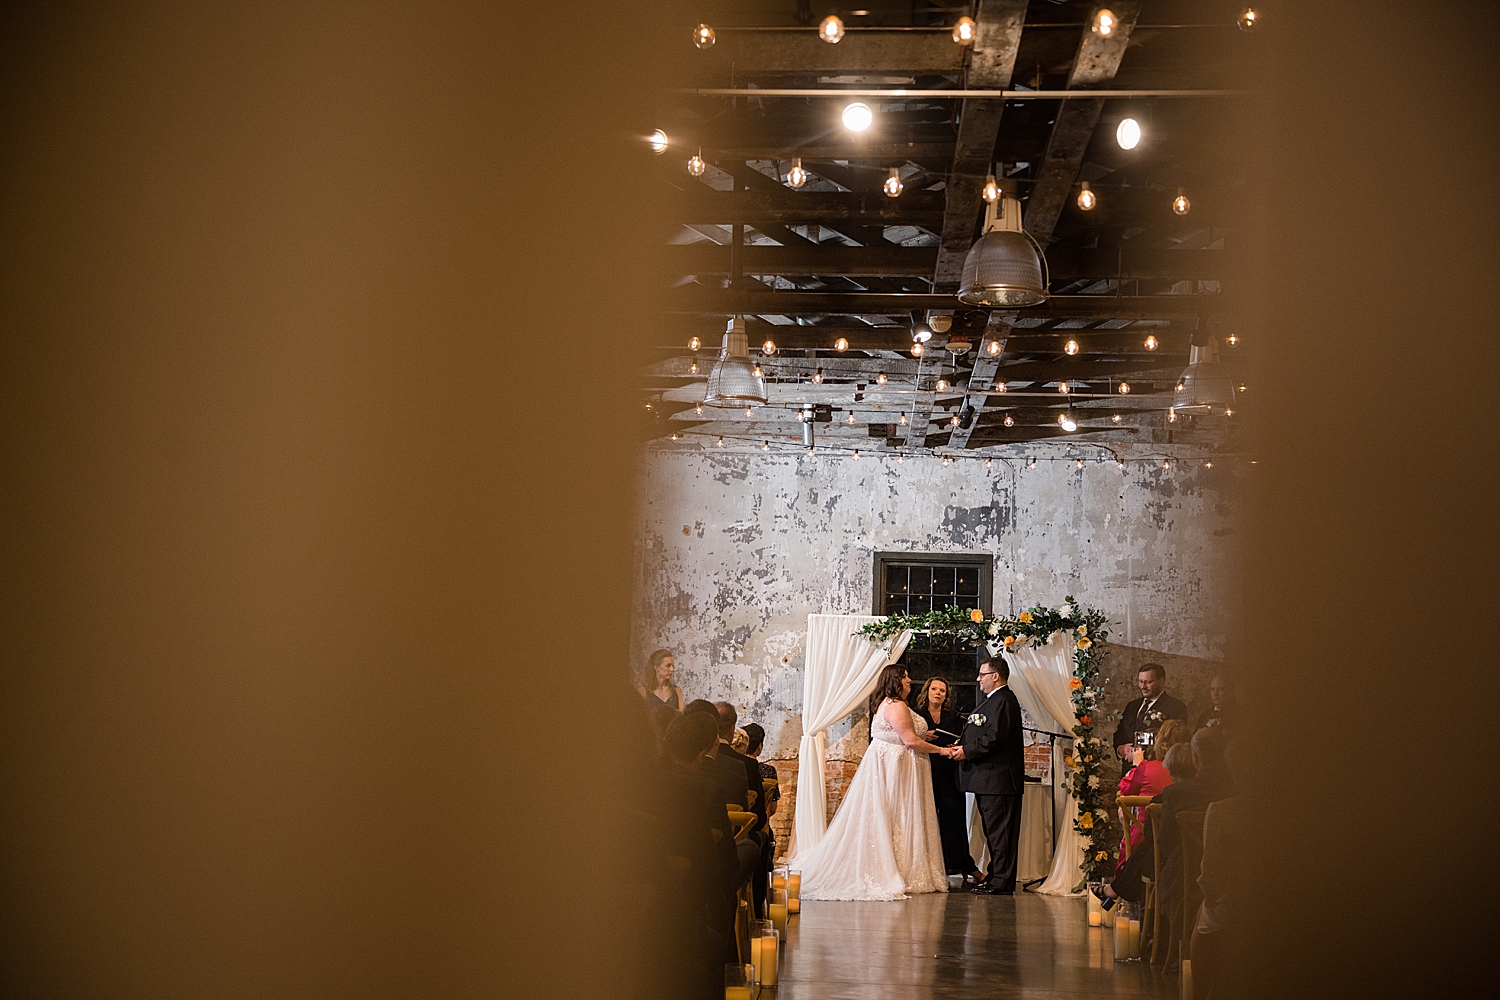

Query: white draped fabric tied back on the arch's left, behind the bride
[792,615,912,856]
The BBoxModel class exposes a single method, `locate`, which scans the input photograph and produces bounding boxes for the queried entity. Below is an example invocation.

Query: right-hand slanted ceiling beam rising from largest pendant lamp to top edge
[1025,0,1140,246]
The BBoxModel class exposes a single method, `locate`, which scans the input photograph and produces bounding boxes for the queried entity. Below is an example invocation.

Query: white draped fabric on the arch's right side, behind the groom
[1004,633,1083,895]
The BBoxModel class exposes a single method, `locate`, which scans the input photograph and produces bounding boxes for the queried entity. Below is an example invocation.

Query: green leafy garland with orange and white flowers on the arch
[857,597,1115,882]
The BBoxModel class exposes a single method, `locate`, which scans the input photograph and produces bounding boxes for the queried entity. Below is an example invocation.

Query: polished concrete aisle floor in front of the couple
[779,892,1179,1000]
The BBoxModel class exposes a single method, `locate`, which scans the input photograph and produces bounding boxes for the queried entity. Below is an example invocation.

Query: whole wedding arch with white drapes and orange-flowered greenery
[792,597,1115,894]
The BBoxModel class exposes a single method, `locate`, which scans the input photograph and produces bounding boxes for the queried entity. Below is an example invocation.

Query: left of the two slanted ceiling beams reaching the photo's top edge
[933,0,1026,291]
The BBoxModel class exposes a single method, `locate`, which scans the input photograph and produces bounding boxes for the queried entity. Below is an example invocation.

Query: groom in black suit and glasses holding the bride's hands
[953,652,1026,895]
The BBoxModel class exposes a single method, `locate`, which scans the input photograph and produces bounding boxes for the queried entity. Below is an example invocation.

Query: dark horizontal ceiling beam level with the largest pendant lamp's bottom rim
[663,285,1238,319]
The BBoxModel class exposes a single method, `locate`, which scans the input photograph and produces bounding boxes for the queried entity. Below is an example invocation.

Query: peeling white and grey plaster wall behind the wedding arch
[632,448,1238,851]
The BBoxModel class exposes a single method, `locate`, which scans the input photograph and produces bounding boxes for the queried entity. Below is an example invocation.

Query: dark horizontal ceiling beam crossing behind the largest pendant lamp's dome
[662,245,1244,280]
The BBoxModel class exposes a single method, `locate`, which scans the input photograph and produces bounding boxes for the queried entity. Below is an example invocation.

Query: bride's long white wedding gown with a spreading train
[791,702,948,900]
